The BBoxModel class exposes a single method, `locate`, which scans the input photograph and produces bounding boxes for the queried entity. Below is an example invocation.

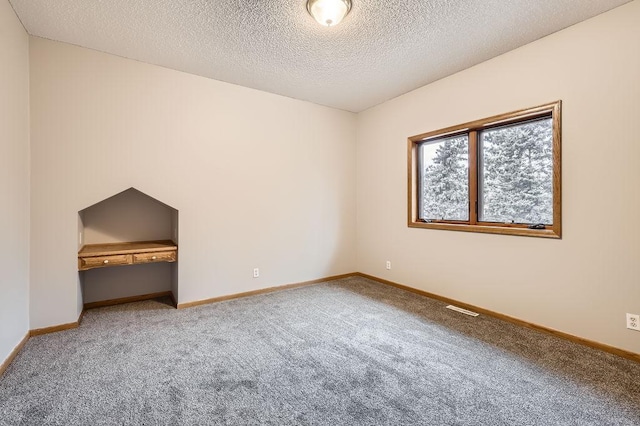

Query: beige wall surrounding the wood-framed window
[357,1,640,353]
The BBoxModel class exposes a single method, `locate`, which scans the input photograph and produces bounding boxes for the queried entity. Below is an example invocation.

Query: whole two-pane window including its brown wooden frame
[408,101,561,238]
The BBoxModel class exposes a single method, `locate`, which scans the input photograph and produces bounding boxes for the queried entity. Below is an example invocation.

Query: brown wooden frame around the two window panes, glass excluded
[407,101,562,239]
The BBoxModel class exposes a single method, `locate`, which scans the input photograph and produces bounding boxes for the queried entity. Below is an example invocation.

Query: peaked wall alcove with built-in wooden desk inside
[78,188,178,307]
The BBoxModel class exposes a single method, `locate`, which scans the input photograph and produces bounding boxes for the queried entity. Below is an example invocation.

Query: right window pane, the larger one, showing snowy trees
[478,118,553,224]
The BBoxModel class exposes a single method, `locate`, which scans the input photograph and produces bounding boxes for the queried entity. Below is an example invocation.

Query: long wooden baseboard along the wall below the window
[353,272,640,363]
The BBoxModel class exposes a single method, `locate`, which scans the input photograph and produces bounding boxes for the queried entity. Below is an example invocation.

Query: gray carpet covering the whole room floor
[0,278,640,426]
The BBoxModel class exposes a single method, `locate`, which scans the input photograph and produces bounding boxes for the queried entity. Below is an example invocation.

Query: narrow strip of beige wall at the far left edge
[0,0,29,364]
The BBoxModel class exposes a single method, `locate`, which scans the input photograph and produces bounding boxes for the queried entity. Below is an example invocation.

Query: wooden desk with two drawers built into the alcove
[78,240,178,271]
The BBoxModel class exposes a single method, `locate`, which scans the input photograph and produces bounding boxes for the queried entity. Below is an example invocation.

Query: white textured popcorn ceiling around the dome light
[8,0,629,112]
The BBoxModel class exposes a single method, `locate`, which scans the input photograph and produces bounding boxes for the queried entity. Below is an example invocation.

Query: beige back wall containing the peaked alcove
[30,37,356,328]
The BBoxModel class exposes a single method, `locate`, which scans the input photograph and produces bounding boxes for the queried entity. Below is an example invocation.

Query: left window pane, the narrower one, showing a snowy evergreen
[418,135,469,221]
